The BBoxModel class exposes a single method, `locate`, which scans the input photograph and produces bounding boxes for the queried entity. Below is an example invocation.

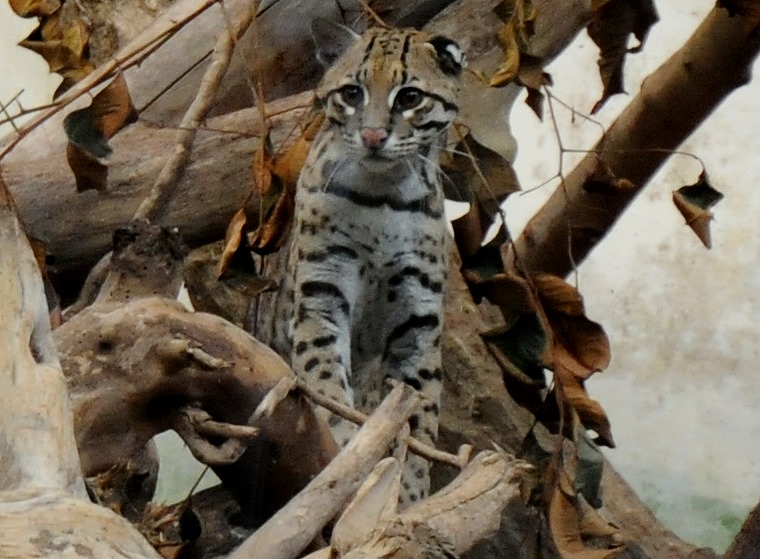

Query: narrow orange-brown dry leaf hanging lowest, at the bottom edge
[547,468,622,559]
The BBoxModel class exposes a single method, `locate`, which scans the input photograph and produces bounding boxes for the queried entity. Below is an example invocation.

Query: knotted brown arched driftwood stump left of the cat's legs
[54,224,337,525]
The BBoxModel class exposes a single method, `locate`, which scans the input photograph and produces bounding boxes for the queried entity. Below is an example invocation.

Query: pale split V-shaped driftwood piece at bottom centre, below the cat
[306,451,526,559]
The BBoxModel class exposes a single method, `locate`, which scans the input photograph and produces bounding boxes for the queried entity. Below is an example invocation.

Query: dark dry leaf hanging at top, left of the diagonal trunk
[588,0,659,114]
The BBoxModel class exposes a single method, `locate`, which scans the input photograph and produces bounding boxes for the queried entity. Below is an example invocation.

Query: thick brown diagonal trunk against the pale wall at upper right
[505,7,760,277]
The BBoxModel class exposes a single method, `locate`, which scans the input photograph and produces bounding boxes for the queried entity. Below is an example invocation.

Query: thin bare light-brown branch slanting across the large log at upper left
[133,2,258,221]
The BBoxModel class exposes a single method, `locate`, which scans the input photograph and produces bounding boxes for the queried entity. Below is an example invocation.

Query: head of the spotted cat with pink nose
[312,19,464,166]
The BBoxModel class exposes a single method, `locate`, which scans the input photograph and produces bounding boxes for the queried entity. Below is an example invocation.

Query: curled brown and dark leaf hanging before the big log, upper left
[63,74,137,192]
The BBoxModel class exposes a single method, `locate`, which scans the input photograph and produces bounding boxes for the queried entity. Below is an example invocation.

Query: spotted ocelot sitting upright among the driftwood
[262,20,463,505]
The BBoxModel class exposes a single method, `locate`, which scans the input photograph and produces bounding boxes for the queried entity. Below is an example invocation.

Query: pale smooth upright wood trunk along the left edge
[0,179,158,559]
